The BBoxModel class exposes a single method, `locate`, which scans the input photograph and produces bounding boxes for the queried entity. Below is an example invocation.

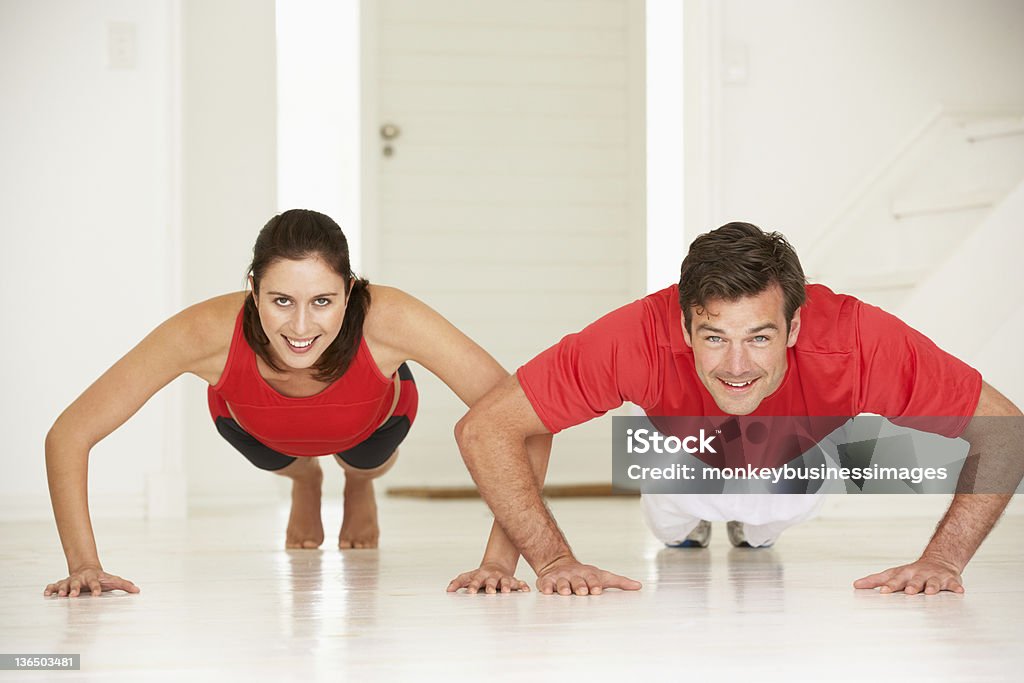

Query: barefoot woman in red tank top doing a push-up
[44,210,551,597]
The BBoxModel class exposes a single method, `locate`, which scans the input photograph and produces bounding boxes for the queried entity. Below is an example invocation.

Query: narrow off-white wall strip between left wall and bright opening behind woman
[181,0,280,505]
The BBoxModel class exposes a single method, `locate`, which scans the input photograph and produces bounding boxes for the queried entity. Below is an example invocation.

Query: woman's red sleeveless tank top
[208,311,394,456]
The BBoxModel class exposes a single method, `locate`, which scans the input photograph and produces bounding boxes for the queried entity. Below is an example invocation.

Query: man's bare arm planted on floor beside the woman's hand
[456,375,640,595]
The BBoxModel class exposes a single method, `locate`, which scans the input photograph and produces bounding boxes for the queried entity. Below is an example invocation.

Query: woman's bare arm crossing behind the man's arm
[365,286,551,593]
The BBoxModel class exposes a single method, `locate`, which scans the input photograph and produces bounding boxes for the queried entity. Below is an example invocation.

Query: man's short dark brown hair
[679,223,807,332]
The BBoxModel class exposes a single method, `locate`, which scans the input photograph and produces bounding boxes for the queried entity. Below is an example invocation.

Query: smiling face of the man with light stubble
[683,285,800,415]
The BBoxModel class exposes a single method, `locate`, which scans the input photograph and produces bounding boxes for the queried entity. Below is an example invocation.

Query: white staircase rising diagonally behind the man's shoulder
[802,108,1024,314]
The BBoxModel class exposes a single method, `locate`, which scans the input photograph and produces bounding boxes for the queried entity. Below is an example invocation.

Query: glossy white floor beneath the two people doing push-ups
[0,498,1024,681]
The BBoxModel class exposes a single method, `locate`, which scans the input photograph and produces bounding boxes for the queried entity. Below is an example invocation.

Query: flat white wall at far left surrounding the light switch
[0,0,177,519]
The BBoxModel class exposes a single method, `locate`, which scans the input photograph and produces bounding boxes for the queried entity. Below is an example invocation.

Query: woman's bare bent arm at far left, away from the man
[44,295,235,597]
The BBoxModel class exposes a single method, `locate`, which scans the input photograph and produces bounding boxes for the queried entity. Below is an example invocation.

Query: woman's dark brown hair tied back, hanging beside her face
[242,209,370,382]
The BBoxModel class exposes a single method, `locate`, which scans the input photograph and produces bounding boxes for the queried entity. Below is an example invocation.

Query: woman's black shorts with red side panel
[214,364,417,472]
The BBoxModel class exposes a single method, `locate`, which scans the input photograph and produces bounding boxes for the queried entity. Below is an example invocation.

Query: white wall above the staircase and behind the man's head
[684,0,1024,393]
